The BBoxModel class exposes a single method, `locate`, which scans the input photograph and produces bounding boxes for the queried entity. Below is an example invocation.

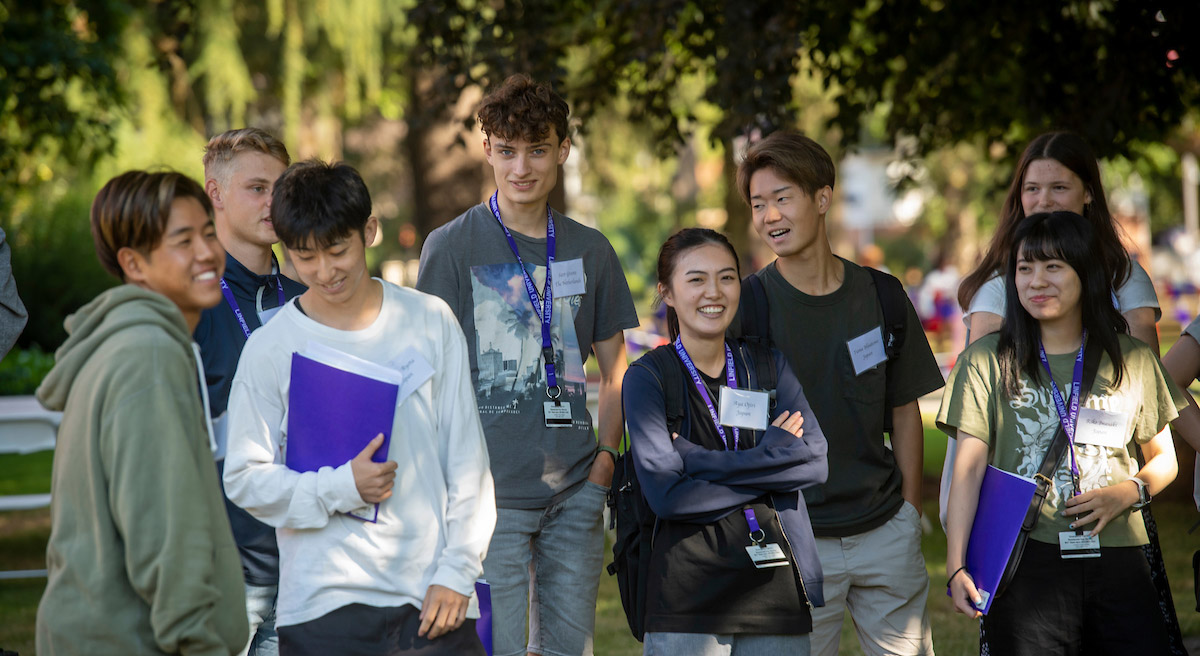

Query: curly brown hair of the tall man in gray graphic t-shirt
[479,74,570,145]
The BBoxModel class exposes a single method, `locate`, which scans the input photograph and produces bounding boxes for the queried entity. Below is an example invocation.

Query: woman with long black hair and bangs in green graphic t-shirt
[937,211,1187,656]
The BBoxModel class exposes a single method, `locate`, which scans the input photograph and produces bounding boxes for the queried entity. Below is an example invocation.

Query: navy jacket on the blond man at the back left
[193,253,307,585]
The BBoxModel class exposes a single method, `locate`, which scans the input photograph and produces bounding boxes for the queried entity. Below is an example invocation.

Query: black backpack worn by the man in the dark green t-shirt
[740,266,908,433]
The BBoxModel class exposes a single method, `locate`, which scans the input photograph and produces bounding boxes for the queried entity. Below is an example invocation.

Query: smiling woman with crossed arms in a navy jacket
[623,228,828,655]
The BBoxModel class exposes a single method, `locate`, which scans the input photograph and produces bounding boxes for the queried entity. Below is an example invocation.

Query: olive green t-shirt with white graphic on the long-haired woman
[937,335,1187,547]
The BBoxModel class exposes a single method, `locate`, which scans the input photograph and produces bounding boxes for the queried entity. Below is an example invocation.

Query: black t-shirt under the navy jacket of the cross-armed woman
[646,362,812,634]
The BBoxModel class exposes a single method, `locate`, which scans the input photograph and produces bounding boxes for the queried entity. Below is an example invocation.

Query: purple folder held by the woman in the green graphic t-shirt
[947,465,1038,615]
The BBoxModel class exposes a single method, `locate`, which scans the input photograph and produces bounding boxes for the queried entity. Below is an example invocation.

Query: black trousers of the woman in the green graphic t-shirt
[983,540,1169,656]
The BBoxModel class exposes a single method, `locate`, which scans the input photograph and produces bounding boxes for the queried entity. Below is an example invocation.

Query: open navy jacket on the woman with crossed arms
[622,343,829,606]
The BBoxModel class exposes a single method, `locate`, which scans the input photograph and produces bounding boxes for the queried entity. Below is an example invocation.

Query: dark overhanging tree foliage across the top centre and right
[410,0,1200,155]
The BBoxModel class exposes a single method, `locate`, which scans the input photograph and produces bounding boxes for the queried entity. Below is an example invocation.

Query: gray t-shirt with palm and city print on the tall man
[416,204,638,508]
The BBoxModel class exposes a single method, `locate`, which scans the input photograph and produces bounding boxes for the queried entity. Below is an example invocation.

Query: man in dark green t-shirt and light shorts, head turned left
[733,132,943,656]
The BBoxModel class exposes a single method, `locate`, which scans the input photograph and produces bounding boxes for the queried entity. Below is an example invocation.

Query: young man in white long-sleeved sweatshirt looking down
[224,161,496,655]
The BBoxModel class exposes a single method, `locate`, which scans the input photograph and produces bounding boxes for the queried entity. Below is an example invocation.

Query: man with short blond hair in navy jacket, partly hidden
[196,127,305,656]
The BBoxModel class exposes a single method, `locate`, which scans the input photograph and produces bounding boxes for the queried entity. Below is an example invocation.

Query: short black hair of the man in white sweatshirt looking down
[271,160,371,249]
